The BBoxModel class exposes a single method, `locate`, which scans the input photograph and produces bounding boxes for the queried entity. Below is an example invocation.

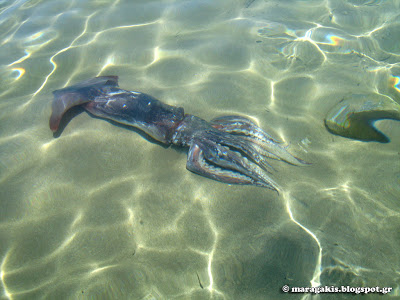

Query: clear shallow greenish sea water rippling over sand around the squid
[0,0,400,299]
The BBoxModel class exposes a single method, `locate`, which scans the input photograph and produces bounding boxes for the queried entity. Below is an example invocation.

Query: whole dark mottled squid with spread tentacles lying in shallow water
[50,76,307,191]
